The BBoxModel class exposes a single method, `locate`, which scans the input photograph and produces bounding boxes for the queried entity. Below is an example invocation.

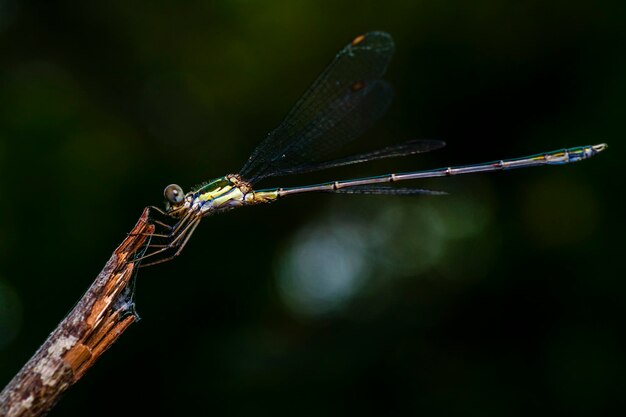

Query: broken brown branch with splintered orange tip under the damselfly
[0,208,154,417]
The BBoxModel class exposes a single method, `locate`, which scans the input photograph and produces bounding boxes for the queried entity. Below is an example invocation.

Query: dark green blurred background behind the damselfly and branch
[0,0,626,416]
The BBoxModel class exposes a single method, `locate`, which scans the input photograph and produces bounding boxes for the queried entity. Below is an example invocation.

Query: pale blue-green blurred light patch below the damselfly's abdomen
[276,193,493,316]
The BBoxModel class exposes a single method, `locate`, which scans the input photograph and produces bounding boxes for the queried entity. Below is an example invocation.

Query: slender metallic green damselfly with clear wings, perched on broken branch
[137,32,607,266]
